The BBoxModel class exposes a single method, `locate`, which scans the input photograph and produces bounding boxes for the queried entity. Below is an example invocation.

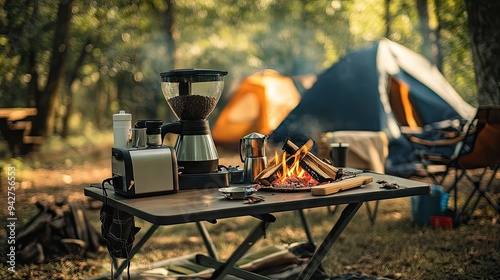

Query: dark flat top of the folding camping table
[84,172,431,225]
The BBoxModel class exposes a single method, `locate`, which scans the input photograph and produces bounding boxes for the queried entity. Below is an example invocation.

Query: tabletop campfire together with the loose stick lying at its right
[255,139,373,195]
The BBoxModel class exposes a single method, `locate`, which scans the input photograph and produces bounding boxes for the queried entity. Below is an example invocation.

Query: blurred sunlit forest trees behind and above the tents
[0,0,498,149]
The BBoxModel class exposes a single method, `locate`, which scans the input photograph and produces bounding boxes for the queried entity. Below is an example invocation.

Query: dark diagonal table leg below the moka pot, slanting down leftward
[200,214,276,280]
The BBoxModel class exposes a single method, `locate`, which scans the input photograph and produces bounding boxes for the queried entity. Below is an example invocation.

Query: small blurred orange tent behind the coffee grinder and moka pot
[212,70,300,144]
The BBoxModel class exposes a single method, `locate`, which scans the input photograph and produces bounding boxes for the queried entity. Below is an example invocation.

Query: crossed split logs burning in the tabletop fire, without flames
[255,139,340,186]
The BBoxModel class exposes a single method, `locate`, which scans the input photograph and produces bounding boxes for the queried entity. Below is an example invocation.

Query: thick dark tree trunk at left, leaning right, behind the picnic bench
[32,0,73,136]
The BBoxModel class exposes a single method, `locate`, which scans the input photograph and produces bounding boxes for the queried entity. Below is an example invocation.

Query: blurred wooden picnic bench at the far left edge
[0,108,43,156]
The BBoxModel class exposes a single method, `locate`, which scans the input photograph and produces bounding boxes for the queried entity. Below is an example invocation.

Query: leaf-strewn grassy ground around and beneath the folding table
[0,137,500,279]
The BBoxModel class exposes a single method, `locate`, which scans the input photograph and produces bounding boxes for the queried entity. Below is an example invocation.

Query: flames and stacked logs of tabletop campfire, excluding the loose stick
[255,139,340,189]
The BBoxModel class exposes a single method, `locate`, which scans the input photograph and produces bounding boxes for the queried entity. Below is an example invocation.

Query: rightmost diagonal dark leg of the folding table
[297,202,363,280]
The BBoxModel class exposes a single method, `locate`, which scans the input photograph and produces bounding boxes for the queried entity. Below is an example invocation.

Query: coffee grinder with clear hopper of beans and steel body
[160,69,229,189]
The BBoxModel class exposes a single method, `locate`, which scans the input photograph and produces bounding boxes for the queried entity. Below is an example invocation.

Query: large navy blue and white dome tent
[269,39,476,175]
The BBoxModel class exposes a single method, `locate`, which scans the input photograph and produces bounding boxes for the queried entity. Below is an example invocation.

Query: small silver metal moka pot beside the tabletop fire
[240,132,268,183]
